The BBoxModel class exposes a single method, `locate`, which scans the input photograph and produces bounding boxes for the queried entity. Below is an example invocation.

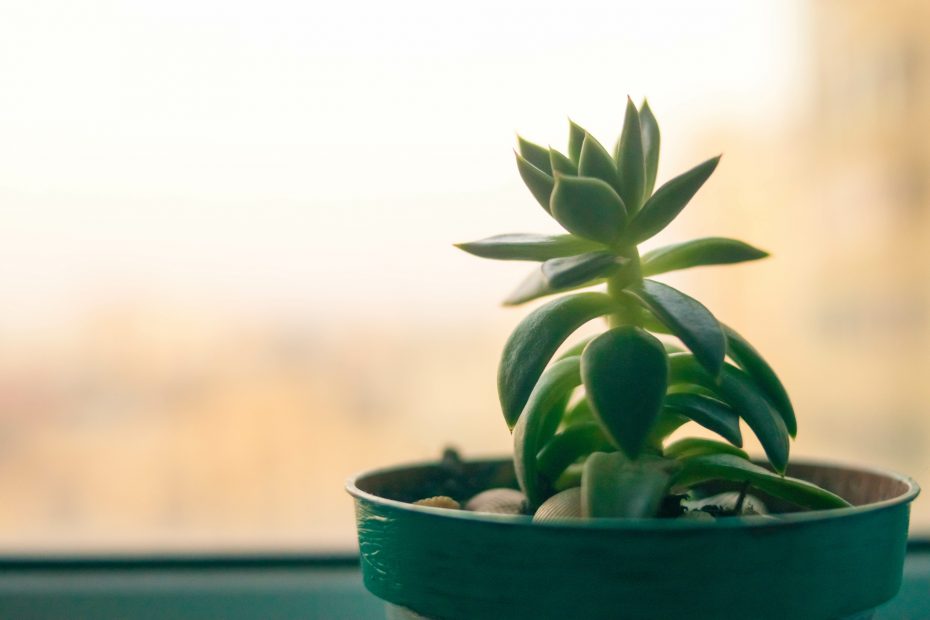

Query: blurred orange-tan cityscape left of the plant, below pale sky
[0,307,507,551]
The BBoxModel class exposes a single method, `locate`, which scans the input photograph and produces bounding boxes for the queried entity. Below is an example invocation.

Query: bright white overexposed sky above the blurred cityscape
[0,0,804,327]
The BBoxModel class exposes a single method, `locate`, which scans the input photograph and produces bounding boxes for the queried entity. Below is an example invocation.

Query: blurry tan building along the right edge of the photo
[795,0,930,452]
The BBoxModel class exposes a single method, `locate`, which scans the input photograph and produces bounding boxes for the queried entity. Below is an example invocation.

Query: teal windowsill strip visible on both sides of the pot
[0,544,930,620]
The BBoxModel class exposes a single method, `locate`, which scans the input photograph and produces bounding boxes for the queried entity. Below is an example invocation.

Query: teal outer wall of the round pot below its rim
[350,462,916,620]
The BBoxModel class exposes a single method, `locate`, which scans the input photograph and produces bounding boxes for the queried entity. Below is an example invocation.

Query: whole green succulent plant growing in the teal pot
[458,101,848,517]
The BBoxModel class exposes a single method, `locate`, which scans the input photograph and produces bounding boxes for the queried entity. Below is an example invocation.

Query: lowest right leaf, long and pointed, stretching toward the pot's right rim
[672,454,850,510]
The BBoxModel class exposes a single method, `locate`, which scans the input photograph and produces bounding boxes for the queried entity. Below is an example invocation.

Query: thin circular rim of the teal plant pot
[345,457,920,531]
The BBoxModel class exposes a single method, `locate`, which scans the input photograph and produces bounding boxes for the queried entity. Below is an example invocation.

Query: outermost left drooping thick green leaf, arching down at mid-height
[497,293,614,428]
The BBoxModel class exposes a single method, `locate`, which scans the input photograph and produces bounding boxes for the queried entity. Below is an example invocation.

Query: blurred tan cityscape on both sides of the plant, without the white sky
[0,0,930,551]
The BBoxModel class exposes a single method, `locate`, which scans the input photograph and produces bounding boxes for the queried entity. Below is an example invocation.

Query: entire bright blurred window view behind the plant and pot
[0,0,930,552]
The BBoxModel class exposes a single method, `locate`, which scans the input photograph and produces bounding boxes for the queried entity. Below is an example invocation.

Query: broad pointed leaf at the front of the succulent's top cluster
[549,176,626,245]
